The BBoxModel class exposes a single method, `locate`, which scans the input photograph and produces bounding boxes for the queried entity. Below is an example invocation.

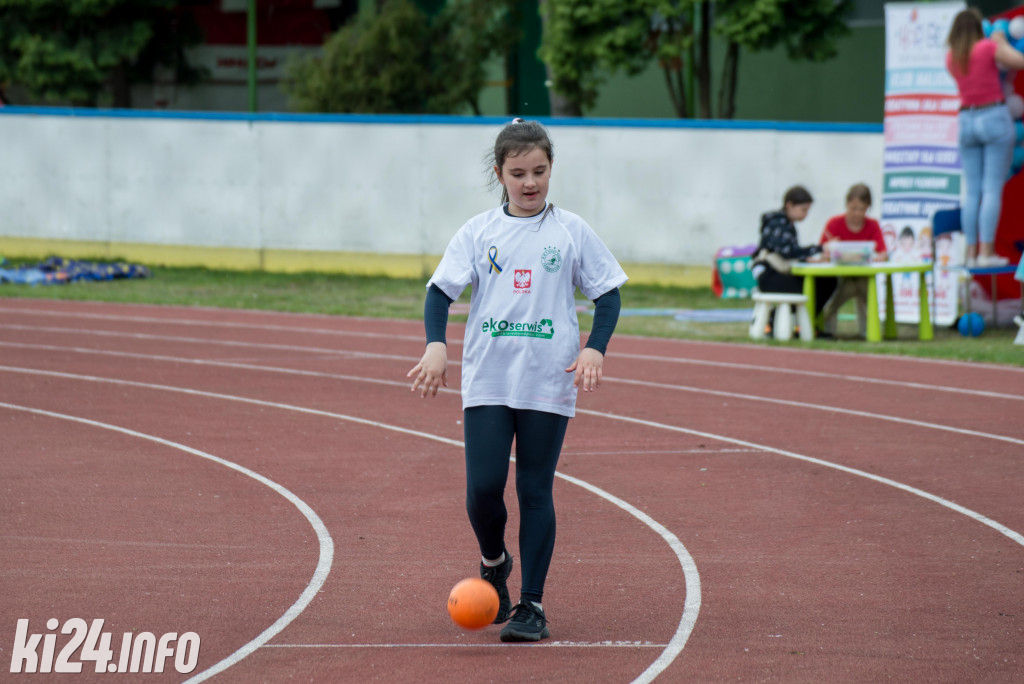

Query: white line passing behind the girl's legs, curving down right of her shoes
[0,367,700,684]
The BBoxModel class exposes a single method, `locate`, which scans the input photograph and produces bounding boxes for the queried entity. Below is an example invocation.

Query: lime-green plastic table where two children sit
[792,261,935,342]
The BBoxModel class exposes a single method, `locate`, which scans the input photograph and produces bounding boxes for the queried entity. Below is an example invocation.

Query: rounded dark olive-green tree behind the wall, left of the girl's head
[284,0,515,115]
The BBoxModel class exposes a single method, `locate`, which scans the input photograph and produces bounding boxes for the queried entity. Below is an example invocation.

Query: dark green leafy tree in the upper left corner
[0,0,199,106]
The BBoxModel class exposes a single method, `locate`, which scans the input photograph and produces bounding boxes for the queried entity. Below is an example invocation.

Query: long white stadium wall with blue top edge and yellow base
[0,108,883,284]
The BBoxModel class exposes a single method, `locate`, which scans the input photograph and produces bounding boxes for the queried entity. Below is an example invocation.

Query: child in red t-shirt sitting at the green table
[820,183,888,337]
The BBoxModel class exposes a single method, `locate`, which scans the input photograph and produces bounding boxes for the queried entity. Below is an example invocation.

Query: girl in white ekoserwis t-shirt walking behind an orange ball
[408,119,627,641]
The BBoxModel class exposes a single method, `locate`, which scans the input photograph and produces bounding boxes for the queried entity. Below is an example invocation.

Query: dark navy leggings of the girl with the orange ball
[464,407,569,602]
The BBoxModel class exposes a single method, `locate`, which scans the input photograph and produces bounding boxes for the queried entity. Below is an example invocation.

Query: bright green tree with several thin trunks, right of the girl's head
[541,0,852,118]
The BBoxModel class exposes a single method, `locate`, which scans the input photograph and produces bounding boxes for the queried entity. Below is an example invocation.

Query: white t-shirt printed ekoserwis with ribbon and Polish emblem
[427,202,627,418]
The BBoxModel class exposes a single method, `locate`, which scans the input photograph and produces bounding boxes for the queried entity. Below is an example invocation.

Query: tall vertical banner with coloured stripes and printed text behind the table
[882,2,966,325]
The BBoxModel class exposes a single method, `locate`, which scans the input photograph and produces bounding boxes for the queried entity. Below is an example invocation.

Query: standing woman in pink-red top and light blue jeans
[946,7,1024,266]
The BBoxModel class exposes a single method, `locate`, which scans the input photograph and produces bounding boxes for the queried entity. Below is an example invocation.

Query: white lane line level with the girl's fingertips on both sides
[0,342,1024,444]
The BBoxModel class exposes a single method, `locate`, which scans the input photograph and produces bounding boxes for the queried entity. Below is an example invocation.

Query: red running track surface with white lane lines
[0,299,1024,682]
